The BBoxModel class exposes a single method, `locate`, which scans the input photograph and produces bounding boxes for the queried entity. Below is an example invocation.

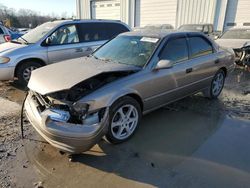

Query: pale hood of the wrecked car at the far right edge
[215,39,250,49]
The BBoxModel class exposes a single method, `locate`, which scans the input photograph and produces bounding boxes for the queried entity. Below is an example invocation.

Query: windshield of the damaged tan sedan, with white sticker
[93,36,159,67]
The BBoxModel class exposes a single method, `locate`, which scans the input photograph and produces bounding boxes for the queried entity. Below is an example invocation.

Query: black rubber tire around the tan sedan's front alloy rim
[106,97,142,144]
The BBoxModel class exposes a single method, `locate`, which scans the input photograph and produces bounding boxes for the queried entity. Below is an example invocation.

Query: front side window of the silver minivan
[50,25,79,45]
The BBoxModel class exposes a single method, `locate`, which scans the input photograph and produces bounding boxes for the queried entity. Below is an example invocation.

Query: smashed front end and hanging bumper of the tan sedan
[25,71,134,153]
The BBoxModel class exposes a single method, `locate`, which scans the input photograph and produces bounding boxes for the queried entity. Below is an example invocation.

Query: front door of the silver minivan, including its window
[48,24,82,63]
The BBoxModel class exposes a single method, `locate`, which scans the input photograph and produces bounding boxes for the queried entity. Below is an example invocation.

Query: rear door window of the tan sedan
[189,37,213,58]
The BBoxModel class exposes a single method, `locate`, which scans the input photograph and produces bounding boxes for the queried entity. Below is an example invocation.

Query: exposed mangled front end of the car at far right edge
[234,46,250,67]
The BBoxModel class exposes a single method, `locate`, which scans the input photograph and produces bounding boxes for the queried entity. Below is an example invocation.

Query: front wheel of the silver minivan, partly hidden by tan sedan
[16,62,42,86]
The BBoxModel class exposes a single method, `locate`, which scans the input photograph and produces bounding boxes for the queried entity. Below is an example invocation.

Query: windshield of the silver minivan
[18,22,59,43]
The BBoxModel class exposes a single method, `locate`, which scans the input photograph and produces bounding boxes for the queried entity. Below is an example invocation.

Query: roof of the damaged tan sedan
[120,30,204,39]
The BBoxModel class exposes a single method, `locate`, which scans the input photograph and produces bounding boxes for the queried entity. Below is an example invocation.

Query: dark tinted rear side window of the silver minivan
[78,23,128,42]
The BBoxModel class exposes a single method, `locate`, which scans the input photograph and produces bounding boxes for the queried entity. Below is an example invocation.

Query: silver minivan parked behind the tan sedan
[0,20,130,85]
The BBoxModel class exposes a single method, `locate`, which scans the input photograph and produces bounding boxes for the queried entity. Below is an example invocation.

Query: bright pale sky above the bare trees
[0,0,76,17]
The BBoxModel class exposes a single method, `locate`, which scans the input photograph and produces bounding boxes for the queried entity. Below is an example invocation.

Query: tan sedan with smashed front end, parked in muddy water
[25,31,234,153]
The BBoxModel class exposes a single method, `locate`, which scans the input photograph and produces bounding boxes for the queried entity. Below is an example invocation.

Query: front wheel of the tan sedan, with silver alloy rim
[106,97,141,144]
